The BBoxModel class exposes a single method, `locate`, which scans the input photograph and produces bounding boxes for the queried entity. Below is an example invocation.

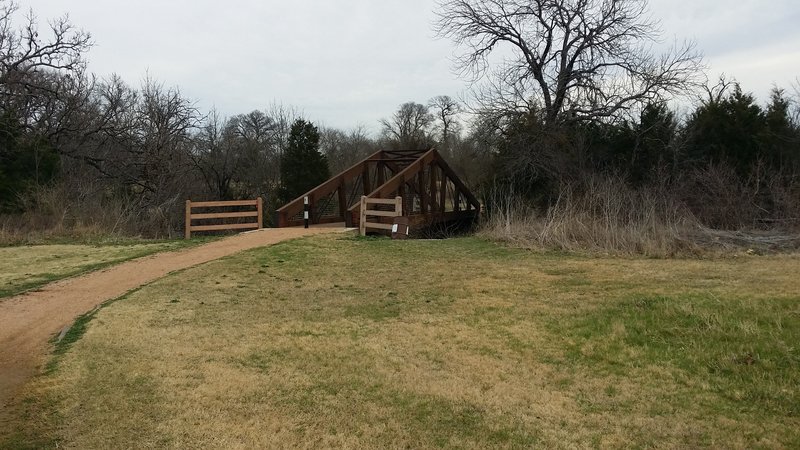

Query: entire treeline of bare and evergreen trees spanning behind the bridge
[0,0,800,243]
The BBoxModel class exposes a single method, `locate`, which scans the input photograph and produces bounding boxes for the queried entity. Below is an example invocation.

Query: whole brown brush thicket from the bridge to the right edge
[481,165,800,257]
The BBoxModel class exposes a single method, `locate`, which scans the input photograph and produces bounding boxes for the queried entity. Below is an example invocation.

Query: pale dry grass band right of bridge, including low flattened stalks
[480,176,800,258]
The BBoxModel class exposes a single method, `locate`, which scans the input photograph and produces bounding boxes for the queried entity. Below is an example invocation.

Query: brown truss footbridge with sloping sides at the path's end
[275,149,480,232]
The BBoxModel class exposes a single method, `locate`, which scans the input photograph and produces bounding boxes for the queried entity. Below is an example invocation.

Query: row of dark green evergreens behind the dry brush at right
[490,81,800,229]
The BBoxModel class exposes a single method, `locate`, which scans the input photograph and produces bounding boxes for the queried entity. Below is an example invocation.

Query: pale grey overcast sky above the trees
[18,0,800,131]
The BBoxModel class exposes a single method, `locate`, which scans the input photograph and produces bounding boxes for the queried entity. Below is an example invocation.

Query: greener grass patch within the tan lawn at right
[550,294,800,417]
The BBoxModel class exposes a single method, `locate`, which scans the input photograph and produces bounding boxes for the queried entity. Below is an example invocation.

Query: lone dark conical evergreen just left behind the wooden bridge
[280,119,330,203]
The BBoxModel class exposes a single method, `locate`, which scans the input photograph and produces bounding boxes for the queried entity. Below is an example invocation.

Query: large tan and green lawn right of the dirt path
[0,236,800,448]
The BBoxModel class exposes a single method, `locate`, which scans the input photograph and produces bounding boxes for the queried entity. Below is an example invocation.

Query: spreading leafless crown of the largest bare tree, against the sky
[436,0,701,124]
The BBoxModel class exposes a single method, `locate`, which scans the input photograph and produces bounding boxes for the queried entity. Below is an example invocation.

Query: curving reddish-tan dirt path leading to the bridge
[0,225,344,415]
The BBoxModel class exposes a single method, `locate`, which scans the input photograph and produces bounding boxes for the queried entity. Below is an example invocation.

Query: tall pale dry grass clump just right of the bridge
[482,176,696,256]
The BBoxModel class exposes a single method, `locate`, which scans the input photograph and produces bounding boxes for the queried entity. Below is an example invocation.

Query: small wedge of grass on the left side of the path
[0,240,209,301]
